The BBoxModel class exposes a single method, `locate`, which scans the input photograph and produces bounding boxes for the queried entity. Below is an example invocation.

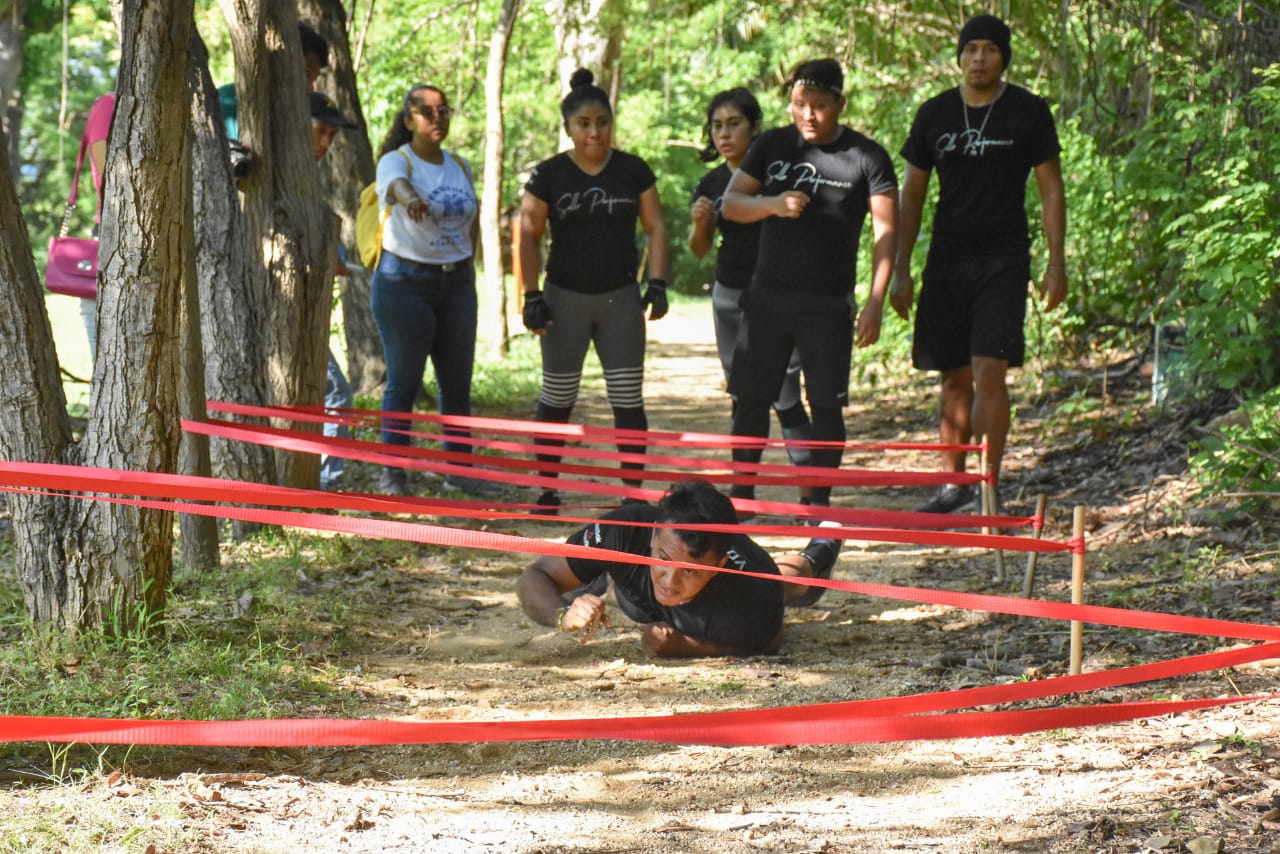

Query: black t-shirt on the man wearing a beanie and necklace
[901,83,1061,252]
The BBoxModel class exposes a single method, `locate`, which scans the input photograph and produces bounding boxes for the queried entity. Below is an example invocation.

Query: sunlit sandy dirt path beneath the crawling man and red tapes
[0,311,1280,854]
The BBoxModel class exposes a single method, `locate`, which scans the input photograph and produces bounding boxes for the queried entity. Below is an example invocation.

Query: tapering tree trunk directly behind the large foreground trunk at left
[191,30,275,539]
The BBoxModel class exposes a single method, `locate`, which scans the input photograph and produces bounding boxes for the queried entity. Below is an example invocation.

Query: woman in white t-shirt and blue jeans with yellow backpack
[370,86,488,495]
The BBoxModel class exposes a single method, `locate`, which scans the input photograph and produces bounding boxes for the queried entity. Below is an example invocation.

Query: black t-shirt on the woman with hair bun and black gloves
[525,149,657,293]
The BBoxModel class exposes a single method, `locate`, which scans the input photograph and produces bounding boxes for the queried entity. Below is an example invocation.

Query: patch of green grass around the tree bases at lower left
[0,529,430,778]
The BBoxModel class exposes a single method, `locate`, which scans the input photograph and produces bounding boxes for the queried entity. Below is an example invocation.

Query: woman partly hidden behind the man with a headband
[689,87,813,503]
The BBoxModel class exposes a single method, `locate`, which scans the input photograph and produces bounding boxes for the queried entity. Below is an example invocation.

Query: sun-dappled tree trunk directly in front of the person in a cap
[223,0,338,489]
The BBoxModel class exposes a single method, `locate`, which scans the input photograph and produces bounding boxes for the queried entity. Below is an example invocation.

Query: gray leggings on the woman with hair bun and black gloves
[538,282,645,408]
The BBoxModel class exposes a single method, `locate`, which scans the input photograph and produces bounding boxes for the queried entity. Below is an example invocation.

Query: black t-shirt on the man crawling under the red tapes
[567,504,782,653]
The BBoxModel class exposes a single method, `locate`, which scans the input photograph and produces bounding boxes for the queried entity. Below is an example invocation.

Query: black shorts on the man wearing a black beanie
[911,250,1030,371]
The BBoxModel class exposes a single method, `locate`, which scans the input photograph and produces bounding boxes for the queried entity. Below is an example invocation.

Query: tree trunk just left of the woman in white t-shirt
[298,0,387,394]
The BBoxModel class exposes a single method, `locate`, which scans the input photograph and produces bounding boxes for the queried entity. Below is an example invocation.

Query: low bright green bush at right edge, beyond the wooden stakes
[1192,387,1280,512]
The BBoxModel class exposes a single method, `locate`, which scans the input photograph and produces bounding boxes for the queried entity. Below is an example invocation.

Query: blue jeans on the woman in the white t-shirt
[370,251,476,452]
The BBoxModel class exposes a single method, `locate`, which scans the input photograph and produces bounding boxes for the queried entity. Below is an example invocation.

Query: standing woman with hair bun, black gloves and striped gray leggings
[520,68,668,513]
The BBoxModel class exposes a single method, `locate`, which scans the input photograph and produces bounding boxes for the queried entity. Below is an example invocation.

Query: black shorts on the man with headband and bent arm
[728,287,854,408]
